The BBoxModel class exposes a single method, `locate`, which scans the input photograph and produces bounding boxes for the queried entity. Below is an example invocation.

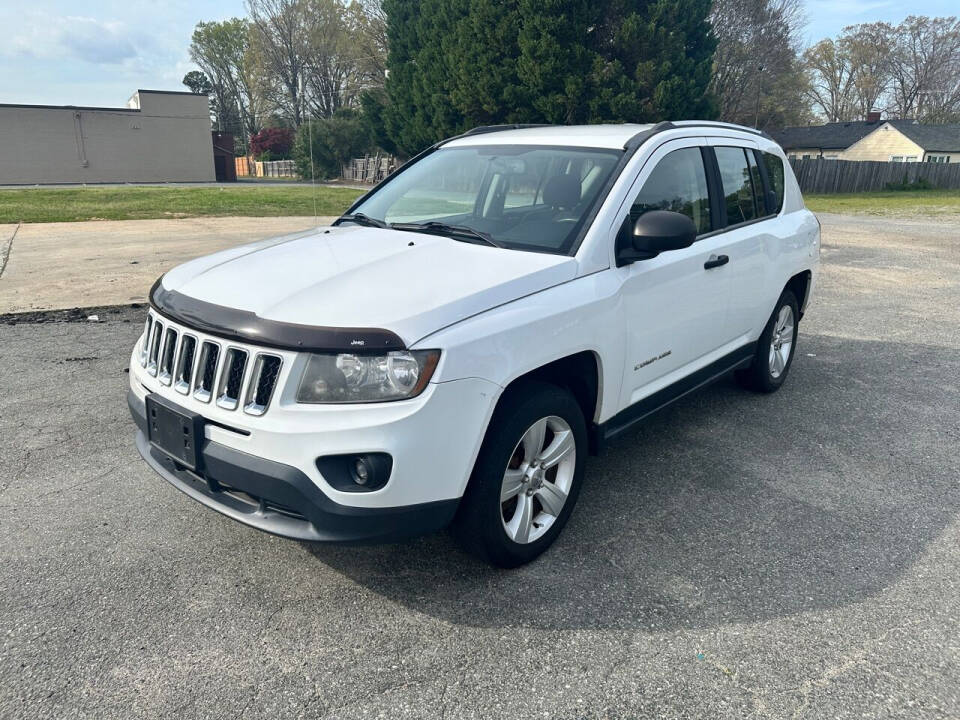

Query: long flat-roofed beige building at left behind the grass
[0,90,215,185]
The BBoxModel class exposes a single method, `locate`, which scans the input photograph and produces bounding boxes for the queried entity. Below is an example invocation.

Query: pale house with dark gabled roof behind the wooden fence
[772,113,960,163]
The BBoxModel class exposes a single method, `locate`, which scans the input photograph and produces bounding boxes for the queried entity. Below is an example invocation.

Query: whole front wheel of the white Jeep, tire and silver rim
[453,382,587,568]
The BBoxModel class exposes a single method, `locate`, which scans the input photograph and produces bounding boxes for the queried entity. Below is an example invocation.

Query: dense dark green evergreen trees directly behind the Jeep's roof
[377,0,716,154]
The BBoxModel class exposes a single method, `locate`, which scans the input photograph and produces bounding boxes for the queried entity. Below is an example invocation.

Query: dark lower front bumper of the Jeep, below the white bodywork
[127,391,459,542]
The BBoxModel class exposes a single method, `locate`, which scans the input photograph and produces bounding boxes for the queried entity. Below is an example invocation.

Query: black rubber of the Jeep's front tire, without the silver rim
[457,383,587,567]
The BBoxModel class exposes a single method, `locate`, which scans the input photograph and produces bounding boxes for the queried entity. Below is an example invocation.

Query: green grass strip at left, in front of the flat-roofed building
[0,185,363,223]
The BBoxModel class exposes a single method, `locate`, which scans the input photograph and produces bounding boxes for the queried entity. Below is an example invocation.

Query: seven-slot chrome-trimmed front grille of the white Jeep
[138,312,283,416]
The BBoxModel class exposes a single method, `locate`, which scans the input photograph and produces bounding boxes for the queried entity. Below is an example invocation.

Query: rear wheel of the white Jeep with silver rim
[736,290,800,393]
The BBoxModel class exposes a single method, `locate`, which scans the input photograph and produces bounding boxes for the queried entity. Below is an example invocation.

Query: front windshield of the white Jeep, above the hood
[344,145,622,253]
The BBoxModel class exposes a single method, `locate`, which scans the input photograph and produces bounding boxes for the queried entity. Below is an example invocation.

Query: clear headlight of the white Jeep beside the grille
[297,350,440,403]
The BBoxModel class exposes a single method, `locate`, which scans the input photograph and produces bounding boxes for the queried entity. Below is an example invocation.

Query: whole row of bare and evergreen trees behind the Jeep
[184,0,960,175]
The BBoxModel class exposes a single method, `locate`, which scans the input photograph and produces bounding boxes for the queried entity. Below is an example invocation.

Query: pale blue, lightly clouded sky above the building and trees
[0,0,958,107]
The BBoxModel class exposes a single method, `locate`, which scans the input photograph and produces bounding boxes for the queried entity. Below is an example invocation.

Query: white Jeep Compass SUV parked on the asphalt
[129,121,819,566]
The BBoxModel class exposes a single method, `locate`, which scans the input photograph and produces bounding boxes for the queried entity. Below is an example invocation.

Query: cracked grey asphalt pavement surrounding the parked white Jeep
[0,216,960,719]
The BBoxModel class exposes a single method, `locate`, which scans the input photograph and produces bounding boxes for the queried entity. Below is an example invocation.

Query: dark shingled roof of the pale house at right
[771,119,960,152]
